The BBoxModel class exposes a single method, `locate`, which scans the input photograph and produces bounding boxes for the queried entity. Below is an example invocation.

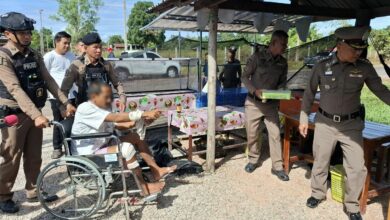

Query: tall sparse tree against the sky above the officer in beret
[50,0,103,42]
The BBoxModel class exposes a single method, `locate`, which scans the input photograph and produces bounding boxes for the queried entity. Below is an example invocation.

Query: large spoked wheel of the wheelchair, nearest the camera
[37,156,106,219]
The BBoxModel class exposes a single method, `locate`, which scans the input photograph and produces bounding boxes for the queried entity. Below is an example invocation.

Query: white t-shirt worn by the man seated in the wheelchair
[72,101,114,155]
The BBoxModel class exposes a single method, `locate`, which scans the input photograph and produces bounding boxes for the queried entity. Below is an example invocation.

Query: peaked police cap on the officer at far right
[334,26,371,49]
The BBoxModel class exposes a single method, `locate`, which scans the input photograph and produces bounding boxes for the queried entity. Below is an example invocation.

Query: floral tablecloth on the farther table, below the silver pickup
[113,93,196,112]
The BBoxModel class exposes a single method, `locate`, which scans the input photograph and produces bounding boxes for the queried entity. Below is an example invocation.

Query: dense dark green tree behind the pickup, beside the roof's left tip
[127,1,165,47]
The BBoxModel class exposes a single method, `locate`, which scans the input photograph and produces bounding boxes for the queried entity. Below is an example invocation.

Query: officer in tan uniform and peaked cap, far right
[299,27,390,220]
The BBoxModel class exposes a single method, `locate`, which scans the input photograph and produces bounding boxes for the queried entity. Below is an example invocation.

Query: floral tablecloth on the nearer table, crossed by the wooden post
[168,106,245,135]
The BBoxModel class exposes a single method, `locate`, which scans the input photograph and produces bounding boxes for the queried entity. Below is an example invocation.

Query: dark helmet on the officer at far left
[0,12,35,33]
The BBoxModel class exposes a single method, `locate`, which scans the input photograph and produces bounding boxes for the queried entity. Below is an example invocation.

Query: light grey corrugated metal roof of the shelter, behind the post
[142,5,329,33]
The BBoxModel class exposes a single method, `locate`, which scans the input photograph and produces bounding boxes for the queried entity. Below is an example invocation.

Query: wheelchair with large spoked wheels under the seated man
[37,120,157,219]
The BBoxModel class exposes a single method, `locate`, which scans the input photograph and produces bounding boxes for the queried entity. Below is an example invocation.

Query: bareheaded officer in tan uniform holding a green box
[241,30,289,181]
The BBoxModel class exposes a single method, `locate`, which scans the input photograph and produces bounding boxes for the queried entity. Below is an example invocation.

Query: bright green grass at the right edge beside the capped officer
[361,80,390,125]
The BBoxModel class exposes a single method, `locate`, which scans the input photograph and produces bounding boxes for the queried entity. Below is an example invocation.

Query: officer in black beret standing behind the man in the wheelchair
[61,33,126,108]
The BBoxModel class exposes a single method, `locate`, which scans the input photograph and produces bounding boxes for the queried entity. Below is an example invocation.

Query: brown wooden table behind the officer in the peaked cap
[282,111,390,213]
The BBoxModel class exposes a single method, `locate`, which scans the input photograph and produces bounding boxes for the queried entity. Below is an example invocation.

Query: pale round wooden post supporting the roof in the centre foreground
[206,8,218,172]
